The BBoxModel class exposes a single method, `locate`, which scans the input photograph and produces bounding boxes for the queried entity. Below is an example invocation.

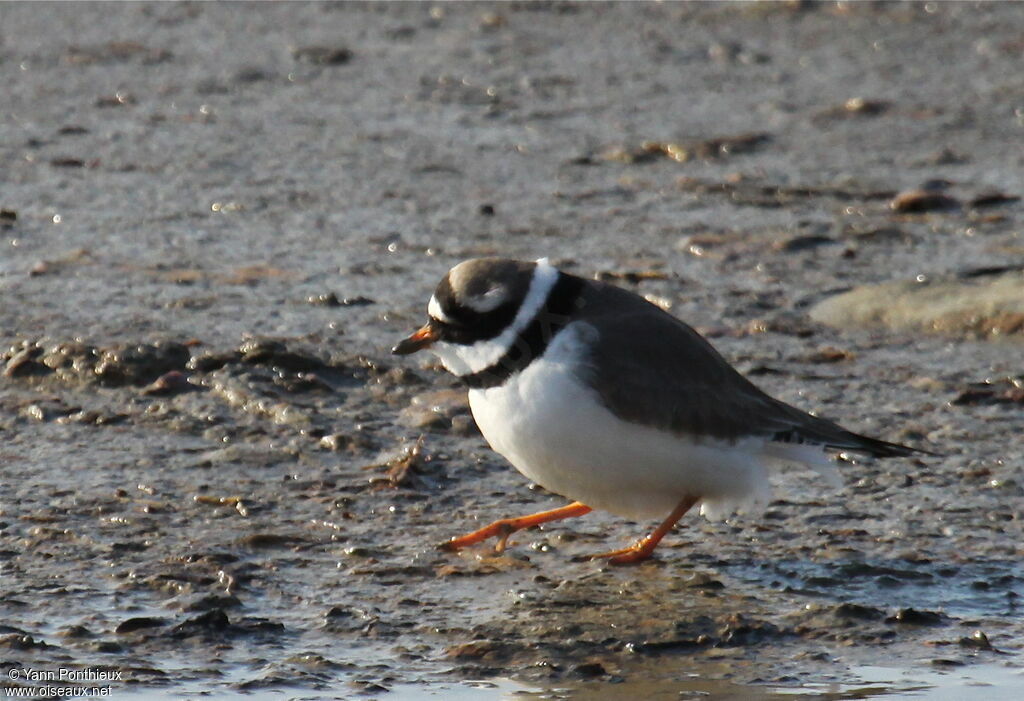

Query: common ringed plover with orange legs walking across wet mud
[393,258,932,564]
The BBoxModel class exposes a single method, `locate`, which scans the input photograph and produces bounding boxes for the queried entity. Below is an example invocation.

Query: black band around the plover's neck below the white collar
[459,272,584,390]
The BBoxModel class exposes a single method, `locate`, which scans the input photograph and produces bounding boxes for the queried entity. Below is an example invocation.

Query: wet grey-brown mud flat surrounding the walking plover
[0,3,1024,698]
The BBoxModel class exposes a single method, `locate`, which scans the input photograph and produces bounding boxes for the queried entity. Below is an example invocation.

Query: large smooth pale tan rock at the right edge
[810,273,1024,338]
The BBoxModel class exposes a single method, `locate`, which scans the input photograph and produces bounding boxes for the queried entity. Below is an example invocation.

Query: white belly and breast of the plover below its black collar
[469,326,771,519]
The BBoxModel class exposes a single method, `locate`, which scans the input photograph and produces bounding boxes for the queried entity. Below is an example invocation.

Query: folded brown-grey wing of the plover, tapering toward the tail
[577,286,918,456]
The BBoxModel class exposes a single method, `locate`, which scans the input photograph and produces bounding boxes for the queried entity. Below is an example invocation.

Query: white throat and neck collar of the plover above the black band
[430,258,558,377]
